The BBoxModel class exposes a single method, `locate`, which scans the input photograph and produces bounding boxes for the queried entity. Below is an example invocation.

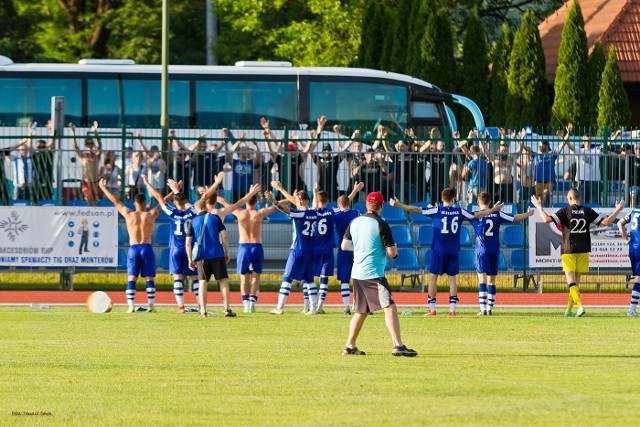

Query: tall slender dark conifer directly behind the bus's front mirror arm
[460,7,489,128]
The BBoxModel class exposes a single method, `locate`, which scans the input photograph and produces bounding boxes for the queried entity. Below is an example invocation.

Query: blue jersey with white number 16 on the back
[422,206,473,252]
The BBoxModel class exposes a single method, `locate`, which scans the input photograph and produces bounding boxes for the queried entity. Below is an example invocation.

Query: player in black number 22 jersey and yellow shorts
[531,188,624,317]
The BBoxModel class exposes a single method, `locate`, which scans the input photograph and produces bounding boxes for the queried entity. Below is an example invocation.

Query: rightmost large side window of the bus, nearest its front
[309,81,407,129]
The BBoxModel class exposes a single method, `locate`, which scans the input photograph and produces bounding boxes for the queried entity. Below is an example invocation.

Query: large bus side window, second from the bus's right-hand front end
[196,81,298,129]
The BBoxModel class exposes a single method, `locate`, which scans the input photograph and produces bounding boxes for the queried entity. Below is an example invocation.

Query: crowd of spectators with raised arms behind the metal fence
[0,116,640,206]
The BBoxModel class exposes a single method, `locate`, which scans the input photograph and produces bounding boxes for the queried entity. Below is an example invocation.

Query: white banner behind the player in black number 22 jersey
[528,208,631,268]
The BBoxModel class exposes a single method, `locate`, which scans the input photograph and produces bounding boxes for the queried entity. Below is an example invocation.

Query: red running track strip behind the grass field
[0,289,630,307]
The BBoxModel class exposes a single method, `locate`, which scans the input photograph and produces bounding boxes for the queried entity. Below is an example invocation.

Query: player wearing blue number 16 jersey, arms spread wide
[389,188,503,316]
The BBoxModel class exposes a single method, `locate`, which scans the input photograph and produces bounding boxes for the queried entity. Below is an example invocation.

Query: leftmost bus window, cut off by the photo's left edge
[0,78,81,126]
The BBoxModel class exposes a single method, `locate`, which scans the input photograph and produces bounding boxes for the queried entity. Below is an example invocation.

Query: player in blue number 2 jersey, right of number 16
[471,191,535,316]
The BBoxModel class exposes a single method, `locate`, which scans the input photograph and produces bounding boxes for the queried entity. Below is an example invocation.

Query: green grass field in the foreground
[0,307,640,426]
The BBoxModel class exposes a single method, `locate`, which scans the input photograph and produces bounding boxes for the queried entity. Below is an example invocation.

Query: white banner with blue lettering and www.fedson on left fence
[0,206,118,267]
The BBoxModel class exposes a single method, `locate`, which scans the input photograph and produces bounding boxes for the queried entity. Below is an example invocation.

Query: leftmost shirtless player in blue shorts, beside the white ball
[98,178,160,313]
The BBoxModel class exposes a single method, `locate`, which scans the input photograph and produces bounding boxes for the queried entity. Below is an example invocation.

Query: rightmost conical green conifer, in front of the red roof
[598,45,631,129]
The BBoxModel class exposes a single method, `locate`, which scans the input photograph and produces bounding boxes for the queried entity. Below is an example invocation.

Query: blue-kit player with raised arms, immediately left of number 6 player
[265,181,318,315]
